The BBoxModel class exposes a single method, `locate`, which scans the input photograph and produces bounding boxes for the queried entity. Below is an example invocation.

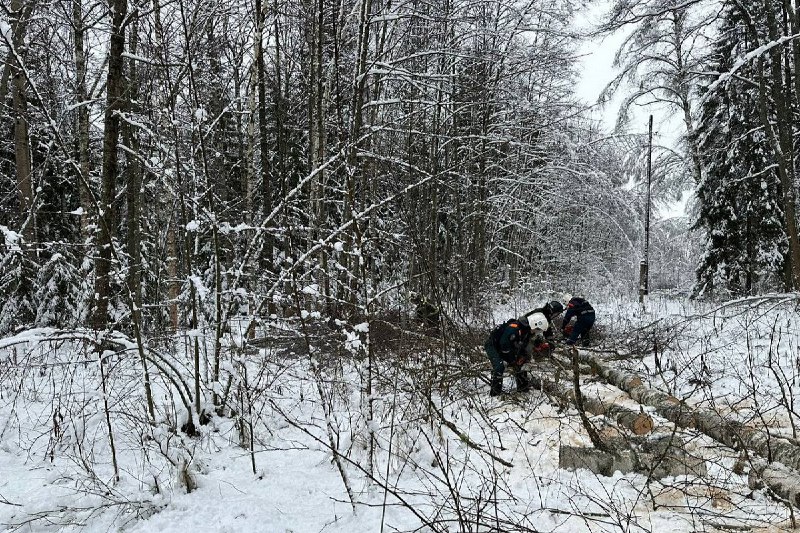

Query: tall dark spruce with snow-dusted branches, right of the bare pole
[694,4,788,296]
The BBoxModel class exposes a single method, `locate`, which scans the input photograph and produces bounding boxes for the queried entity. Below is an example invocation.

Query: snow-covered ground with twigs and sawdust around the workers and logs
[0,295,800,533]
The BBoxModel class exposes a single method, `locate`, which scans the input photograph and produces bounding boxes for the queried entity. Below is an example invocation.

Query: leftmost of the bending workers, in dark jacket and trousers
[484,317,531,396]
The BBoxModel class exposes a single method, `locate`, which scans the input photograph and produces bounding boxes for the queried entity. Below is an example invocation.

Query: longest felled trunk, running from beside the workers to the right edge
[578,352,800,506]
